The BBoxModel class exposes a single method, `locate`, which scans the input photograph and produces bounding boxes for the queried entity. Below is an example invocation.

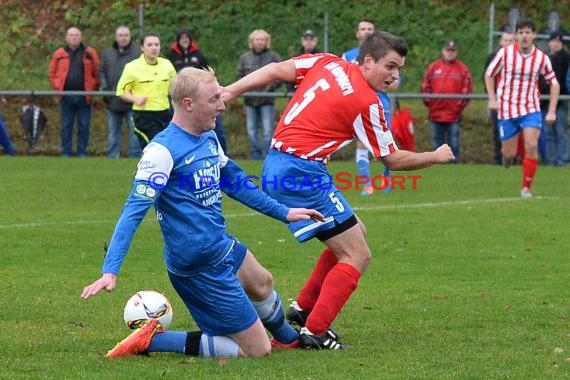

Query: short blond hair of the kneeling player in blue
[169,67,216,108]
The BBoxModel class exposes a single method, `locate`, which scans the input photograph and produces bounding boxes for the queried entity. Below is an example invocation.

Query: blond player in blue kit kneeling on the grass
[81,68,323,358]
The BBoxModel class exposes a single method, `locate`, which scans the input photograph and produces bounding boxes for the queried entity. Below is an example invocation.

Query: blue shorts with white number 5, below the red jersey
[262,149,354,242]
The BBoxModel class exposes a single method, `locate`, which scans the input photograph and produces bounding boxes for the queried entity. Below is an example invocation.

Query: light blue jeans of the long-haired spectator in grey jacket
[245,104,275,160]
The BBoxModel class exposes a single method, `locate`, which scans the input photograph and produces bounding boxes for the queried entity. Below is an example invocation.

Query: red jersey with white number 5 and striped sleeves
[272,54,397,163]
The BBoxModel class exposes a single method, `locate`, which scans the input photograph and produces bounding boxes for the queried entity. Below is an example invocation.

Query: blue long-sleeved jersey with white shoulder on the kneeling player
[103,123,289,275]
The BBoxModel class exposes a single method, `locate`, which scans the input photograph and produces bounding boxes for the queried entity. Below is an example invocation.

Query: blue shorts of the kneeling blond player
[168,239,258,336]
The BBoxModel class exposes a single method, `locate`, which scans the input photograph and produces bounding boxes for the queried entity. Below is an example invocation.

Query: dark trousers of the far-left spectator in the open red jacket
[60,96,91,157]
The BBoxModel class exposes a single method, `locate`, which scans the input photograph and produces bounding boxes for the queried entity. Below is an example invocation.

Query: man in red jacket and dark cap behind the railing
[421,41,473,162]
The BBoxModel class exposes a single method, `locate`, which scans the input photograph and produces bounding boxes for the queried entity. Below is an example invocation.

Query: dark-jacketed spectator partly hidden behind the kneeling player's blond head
[166,29,228,154]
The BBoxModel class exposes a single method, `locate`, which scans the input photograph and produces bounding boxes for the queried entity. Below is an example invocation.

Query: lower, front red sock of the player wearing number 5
[299,260,360,335]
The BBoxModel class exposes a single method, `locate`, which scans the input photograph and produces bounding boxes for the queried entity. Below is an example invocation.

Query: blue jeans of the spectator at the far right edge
[544,100,568,166]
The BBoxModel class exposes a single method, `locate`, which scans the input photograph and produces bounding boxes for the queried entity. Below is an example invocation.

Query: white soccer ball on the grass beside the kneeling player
[123,290,172,330]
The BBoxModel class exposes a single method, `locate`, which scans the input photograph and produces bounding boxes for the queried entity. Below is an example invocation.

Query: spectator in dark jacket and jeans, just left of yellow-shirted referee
[99,26,141,158]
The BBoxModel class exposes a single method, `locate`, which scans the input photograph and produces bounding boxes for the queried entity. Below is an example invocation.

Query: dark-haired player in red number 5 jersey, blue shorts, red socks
[224,32,454,349]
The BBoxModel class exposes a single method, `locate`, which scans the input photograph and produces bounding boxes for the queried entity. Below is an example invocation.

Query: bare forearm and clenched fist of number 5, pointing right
[382,144,455,170]
